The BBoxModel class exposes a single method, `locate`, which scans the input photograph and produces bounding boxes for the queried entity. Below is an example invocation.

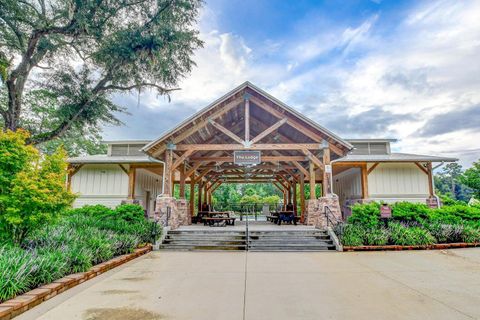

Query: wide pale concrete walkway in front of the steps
[17,248,480,320]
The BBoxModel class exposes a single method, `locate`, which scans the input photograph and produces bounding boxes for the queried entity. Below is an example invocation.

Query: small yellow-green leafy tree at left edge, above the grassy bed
[0,130,75,243]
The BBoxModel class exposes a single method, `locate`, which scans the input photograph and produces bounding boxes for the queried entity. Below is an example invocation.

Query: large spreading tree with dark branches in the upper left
[0,0,202,144]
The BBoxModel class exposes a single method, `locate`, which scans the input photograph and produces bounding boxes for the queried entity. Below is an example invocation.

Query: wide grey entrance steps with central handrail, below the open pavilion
[160,229,335,251]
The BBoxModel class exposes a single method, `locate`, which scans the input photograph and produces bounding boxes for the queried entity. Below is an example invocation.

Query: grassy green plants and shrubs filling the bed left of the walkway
[0,206,161,302]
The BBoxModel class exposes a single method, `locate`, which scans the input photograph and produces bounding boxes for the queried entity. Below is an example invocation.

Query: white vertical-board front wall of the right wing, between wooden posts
[368,163,429,202]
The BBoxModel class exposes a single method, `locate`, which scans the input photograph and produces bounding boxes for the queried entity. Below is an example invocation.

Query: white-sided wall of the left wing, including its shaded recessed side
[71,164,162,214]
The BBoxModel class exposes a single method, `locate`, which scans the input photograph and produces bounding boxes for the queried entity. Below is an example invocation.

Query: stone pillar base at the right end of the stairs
[304,196,342,229]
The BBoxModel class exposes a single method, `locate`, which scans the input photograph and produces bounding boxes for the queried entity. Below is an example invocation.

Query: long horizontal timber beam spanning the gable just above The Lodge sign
[176,143,320,151]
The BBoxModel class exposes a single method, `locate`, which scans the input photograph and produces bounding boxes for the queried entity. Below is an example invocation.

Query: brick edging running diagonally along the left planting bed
[0,245,152,320]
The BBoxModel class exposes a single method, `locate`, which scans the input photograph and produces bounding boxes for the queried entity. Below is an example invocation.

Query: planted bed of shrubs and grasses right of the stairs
[335,202,480,251]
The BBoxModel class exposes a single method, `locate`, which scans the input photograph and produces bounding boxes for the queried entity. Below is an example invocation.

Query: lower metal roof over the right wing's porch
[332,153,458,162]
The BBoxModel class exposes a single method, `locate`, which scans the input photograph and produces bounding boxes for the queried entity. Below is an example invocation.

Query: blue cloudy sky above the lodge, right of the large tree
[104,0,480,167]
